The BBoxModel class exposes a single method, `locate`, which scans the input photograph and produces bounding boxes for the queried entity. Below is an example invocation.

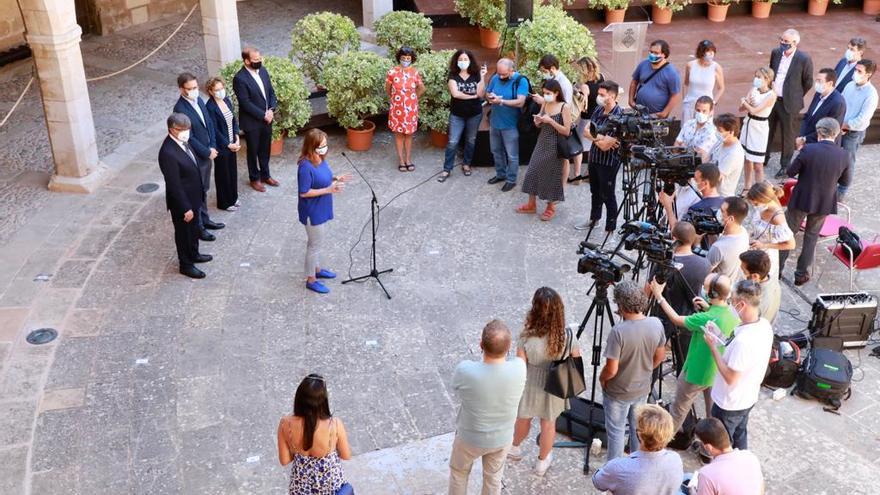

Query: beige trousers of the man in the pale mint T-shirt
[449,435,513,495]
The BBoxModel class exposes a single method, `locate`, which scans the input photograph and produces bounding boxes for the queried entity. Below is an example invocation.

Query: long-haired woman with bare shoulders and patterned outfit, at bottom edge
[278,373,354,495]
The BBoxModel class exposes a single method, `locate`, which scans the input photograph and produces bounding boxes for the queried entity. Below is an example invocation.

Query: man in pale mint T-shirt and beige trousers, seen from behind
[449,320,526,495]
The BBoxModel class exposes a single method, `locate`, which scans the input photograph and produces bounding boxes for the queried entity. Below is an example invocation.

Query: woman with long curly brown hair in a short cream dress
[508,287,581,476]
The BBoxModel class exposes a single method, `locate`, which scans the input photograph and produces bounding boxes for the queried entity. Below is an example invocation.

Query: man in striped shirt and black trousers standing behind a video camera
[575,81,623,233]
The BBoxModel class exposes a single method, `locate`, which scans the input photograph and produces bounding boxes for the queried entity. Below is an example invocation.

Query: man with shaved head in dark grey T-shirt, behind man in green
[645,222,709,373]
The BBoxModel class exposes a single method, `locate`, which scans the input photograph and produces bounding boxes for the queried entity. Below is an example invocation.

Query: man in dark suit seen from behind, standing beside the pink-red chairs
[779,117,852,285]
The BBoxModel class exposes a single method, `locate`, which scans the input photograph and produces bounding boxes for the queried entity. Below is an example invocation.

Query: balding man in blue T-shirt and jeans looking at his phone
[486,58,529,192]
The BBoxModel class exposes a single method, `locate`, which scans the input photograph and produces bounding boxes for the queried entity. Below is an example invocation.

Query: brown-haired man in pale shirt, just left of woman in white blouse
[706,196,749,283]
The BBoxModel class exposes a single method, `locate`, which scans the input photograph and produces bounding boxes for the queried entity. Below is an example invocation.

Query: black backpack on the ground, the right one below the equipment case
[794,348,852,411]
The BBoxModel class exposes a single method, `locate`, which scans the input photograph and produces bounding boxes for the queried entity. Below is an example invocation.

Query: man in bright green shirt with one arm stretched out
[651,273,739,431]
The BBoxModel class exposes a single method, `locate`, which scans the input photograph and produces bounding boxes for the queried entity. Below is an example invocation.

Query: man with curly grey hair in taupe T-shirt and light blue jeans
[599,280,666,461]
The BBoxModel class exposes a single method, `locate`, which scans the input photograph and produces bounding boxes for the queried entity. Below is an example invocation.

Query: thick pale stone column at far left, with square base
[19,0,106,192]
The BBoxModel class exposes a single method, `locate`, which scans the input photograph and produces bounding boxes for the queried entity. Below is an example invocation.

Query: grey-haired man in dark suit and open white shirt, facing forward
[764,29,813,178]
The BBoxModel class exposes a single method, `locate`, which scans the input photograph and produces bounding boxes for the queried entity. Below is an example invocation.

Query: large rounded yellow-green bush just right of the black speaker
[515,5,596,84]
